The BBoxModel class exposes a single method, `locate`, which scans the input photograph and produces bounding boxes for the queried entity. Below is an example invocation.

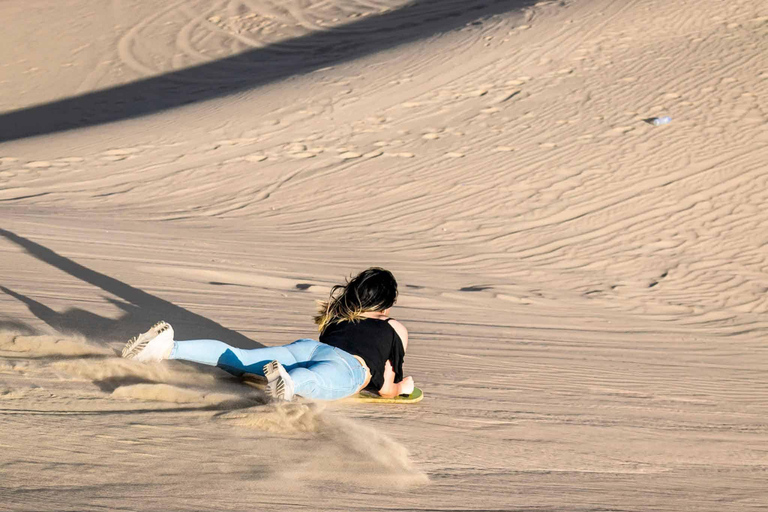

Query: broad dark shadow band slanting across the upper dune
[0,0,534,142]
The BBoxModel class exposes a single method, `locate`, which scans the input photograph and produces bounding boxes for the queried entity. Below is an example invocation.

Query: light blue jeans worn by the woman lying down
[169,338,366,400]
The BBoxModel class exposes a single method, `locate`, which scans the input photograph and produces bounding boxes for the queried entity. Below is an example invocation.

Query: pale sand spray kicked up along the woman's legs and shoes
[0,332,428,487]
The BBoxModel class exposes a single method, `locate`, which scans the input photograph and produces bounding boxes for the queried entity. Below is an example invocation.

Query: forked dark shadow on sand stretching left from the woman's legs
[0,228,263,348]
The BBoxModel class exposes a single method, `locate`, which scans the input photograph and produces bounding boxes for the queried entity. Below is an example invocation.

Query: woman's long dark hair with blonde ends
[315,267,397,332]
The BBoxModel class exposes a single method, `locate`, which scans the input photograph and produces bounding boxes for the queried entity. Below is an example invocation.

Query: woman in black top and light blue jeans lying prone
[123,267,413,401]
